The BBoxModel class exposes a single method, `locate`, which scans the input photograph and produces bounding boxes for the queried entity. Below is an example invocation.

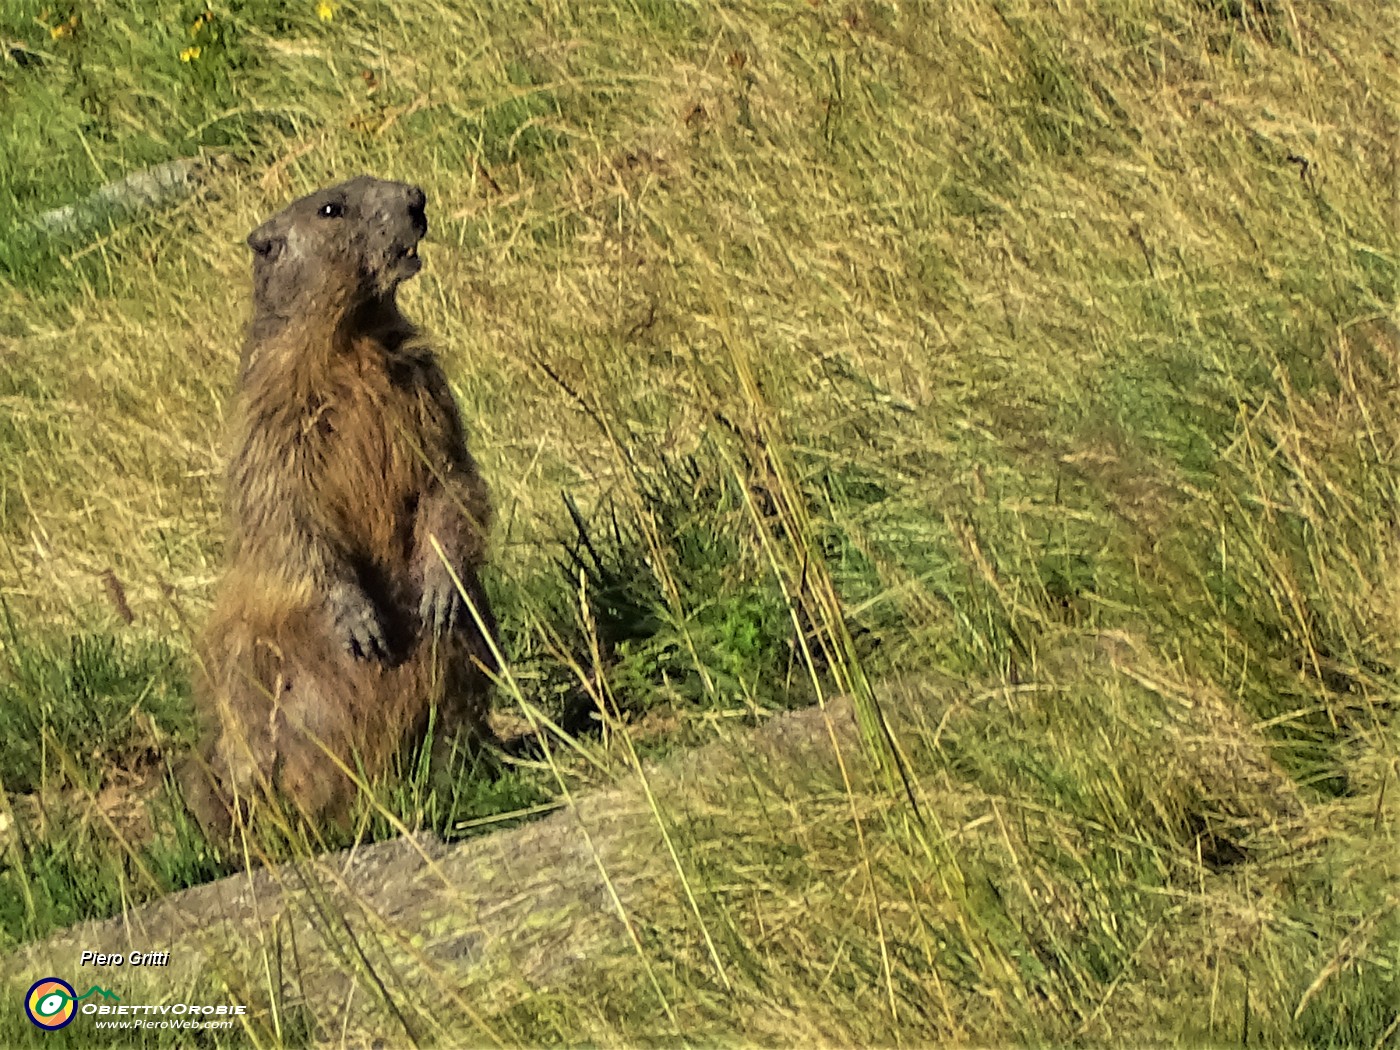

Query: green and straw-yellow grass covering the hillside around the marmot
[0,0,1400,1047]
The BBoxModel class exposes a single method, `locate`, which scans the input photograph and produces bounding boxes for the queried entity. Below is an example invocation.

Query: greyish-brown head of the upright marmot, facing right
[248,175,428,318]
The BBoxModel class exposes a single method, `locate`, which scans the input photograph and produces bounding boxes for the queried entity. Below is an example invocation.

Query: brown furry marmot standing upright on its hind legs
[182,176,496,840]
